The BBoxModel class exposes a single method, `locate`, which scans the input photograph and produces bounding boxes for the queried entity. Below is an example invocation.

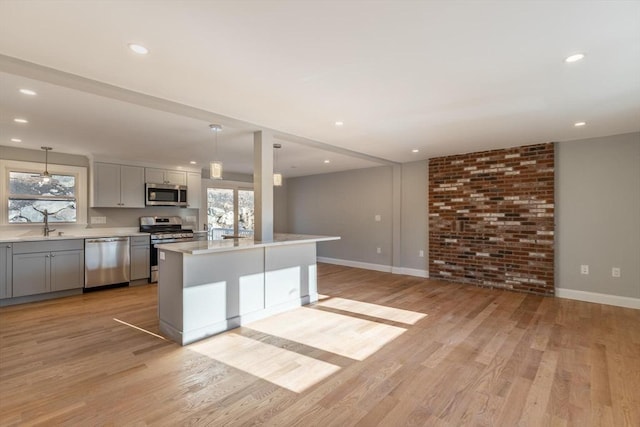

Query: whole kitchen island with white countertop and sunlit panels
[157,234,340,345]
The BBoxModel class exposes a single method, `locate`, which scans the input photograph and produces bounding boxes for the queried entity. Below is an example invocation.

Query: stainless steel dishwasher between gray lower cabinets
[84,237,130,288]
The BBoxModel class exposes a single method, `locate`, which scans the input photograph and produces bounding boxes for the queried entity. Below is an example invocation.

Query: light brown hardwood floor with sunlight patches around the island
[0,264,640,426]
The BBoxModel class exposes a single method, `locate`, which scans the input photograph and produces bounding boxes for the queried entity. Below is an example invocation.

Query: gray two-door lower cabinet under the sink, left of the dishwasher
[12,240,84,298]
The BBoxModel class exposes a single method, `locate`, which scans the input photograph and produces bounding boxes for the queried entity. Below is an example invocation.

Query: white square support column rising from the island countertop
[253,131,273,241]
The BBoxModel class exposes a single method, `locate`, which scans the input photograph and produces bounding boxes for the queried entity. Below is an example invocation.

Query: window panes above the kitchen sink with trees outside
[8,171,77,224]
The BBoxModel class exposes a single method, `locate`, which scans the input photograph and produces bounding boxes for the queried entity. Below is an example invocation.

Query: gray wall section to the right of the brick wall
[556,133,640,298]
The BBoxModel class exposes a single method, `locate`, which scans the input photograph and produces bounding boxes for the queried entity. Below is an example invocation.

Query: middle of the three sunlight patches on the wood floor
[246,307,406,360]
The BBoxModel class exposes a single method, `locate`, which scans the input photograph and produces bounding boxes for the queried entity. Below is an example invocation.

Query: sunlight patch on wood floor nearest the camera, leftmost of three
[189,333,340,393]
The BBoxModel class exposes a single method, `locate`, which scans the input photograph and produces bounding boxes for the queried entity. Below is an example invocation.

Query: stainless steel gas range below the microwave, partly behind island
[140,216,196,282]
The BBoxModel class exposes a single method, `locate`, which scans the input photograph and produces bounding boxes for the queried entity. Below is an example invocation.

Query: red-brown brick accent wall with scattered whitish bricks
[429,143,554,295]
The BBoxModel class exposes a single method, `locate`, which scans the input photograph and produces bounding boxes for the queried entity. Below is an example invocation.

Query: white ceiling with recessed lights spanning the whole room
[0,0,640,176]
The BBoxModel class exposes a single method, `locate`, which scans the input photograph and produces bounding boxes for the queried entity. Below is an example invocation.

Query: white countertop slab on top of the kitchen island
[155,233,340,255]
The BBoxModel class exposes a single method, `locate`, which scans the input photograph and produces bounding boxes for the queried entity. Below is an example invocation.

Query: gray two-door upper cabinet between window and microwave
[91,163,145,208]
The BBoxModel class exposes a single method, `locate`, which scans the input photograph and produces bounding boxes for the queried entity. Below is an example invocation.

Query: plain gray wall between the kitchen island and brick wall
[287,161,428,272]
